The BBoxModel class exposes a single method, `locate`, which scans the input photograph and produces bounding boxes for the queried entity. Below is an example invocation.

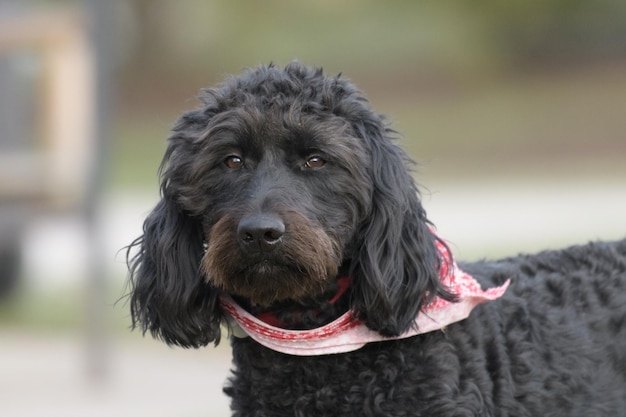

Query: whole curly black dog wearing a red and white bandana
[129,63,626,417]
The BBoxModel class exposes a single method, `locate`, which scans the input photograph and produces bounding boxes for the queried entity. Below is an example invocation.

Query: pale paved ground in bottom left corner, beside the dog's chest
[0,330,230,417]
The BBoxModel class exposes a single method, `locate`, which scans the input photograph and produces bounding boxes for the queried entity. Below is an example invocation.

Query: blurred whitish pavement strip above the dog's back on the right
[424,178,626,259]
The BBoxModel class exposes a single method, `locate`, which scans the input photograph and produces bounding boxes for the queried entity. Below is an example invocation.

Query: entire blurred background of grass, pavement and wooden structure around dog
[0,0,626,417]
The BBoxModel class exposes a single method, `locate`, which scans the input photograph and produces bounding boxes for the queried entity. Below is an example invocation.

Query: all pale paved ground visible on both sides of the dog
[0,180,626,417]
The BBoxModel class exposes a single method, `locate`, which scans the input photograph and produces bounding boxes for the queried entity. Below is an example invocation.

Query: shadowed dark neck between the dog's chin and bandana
[238,275,351,330]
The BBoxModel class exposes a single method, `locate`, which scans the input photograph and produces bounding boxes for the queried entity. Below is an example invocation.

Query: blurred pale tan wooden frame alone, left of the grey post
[0,11,95,209]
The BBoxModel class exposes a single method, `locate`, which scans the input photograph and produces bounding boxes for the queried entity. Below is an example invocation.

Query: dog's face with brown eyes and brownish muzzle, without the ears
[196,109,372,306]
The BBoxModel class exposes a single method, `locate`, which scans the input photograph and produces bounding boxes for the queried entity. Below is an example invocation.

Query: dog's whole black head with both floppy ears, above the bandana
[129,63,451,347]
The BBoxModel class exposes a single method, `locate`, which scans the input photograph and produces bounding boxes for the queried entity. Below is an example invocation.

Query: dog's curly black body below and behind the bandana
[226,242,626,417]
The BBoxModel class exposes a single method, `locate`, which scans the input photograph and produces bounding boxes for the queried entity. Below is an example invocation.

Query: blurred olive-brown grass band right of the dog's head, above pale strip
[387,66,626,162]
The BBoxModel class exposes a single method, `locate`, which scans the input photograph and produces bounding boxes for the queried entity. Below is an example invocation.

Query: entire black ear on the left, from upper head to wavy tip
[127,112,222,347]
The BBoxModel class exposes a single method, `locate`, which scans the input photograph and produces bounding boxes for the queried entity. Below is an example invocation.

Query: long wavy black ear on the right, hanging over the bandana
[352,113,454,336]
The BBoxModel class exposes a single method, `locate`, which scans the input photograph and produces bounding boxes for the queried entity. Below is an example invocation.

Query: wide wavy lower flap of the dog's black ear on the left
[128,198,221,347]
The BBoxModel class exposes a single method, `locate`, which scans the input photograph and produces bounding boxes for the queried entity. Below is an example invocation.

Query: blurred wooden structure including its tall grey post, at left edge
[0,4,115,379]
